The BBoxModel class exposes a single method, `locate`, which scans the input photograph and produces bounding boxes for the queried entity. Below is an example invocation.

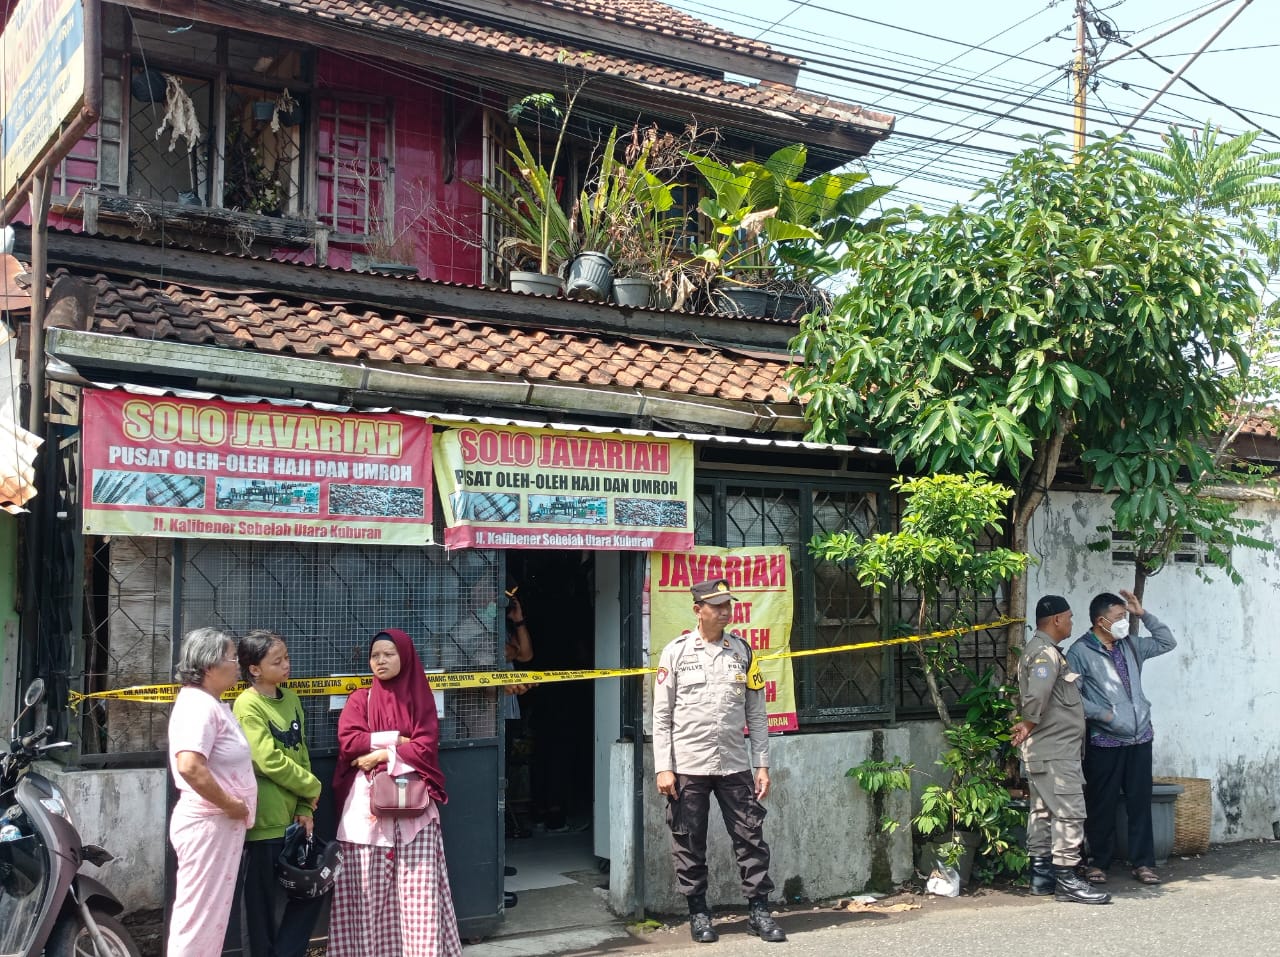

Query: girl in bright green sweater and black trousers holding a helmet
[232,631,325,957]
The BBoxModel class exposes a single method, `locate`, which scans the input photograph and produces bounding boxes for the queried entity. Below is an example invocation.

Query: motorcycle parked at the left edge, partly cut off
[0,678,138,957]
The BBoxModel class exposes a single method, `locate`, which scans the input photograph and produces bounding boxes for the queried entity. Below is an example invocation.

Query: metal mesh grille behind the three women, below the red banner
[179,541,503,754]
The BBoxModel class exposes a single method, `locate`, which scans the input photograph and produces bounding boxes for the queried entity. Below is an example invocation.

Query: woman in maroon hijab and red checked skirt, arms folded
[328,631,462,957]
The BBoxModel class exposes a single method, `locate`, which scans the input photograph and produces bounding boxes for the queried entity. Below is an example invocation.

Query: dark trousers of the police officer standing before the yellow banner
[667,771,773,899]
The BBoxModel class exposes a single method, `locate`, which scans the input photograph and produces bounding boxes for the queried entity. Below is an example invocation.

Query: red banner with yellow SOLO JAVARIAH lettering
[83,390,431,545]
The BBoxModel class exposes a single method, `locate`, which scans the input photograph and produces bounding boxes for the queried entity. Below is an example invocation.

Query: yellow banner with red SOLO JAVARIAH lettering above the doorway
[434,426,694,551]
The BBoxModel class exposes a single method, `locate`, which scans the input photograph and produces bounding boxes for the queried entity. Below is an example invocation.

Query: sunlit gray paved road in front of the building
[478,841,1280,957]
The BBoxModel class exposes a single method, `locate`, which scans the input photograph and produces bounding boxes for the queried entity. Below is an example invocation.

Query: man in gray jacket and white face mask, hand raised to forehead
[1066,589,1178,884]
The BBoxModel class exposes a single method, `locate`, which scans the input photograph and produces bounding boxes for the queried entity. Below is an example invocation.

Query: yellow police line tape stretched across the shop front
[69,618,1025,708]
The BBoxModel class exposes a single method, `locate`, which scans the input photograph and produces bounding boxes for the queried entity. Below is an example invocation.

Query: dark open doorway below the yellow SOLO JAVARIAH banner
[502,551,608,935]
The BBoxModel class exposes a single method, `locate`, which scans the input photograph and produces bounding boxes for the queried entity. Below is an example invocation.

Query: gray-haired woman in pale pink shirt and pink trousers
[166,628,257,957]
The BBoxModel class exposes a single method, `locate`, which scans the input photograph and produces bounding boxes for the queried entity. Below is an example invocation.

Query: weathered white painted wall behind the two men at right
[1028,493,1280,841]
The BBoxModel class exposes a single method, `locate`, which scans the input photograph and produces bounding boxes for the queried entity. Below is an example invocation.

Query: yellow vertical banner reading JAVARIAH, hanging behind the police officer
[646,545,800,733]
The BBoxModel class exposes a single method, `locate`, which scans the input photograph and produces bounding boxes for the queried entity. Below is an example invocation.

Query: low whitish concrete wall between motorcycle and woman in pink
[40,761,169,911]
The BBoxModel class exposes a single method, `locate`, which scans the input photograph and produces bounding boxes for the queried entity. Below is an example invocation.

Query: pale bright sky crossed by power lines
[666,0,1280,212]
